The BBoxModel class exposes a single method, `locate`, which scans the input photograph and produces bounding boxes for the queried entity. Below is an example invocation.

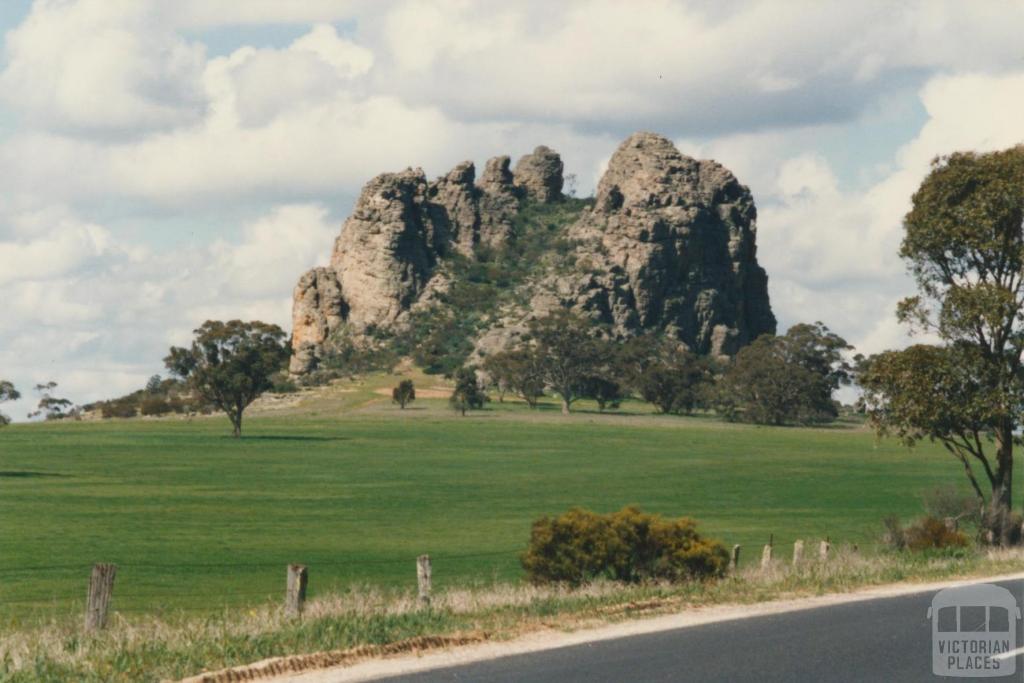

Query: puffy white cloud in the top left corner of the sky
[0,0,205,136]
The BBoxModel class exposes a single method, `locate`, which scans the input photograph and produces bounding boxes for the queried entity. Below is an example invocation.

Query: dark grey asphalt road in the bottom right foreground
[386,581,1024,683]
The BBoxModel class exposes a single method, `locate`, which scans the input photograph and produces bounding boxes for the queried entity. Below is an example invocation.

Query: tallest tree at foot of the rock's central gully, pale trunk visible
[529,308,614,415]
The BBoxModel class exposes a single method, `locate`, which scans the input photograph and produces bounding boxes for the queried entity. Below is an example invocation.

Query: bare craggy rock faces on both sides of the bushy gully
[291,133,775,374]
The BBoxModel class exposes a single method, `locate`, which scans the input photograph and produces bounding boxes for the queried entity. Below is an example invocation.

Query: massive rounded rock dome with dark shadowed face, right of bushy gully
[548,133,775,354]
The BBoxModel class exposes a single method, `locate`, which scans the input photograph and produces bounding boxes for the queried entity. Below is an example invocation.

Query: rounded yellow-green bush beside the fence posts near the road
[522,507,729,586]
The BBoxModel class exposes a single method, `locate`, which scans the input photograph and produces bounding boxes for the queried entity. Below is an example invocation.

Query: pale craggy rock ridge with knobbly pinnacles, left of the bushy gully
[290,147,562,374]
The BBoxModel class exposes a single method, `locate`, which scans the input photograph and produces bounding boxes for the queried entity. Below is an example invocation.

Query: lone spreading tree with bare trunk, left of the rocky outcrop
[164,321,288,437]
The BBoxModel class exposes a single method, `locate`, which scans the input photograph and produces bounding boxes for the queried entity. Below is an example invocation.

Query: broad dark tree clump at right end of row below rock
[716,323,852,425]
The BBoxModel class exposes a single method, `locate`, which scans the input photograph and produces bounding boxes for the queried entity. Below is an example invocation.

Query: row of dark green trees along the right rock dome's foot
[480,309,855,425]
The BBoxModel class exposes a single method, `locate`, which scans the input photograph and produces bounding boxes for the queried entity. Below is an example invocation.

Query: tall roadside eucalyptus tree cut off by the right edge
[860,145,1024,545]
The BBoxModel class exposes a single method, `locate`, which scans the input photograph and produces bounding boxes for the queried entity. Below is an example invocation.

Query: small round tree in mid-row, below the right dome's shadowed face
[634,342,712,415]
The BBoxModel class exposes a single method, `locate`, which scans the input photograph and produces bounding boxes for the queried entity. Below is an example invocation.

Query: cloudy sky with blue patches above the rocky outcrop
[0,0,1024,419]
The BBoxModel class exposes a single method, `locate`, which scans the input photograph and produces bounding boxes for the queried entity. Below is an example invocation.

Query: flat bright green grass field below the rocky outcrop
[0,378,1007,624]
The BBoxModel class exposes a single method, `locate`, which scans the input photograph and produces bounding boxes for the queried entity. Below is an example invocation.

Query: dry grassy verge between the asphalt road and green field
[0,548,1024,683]
